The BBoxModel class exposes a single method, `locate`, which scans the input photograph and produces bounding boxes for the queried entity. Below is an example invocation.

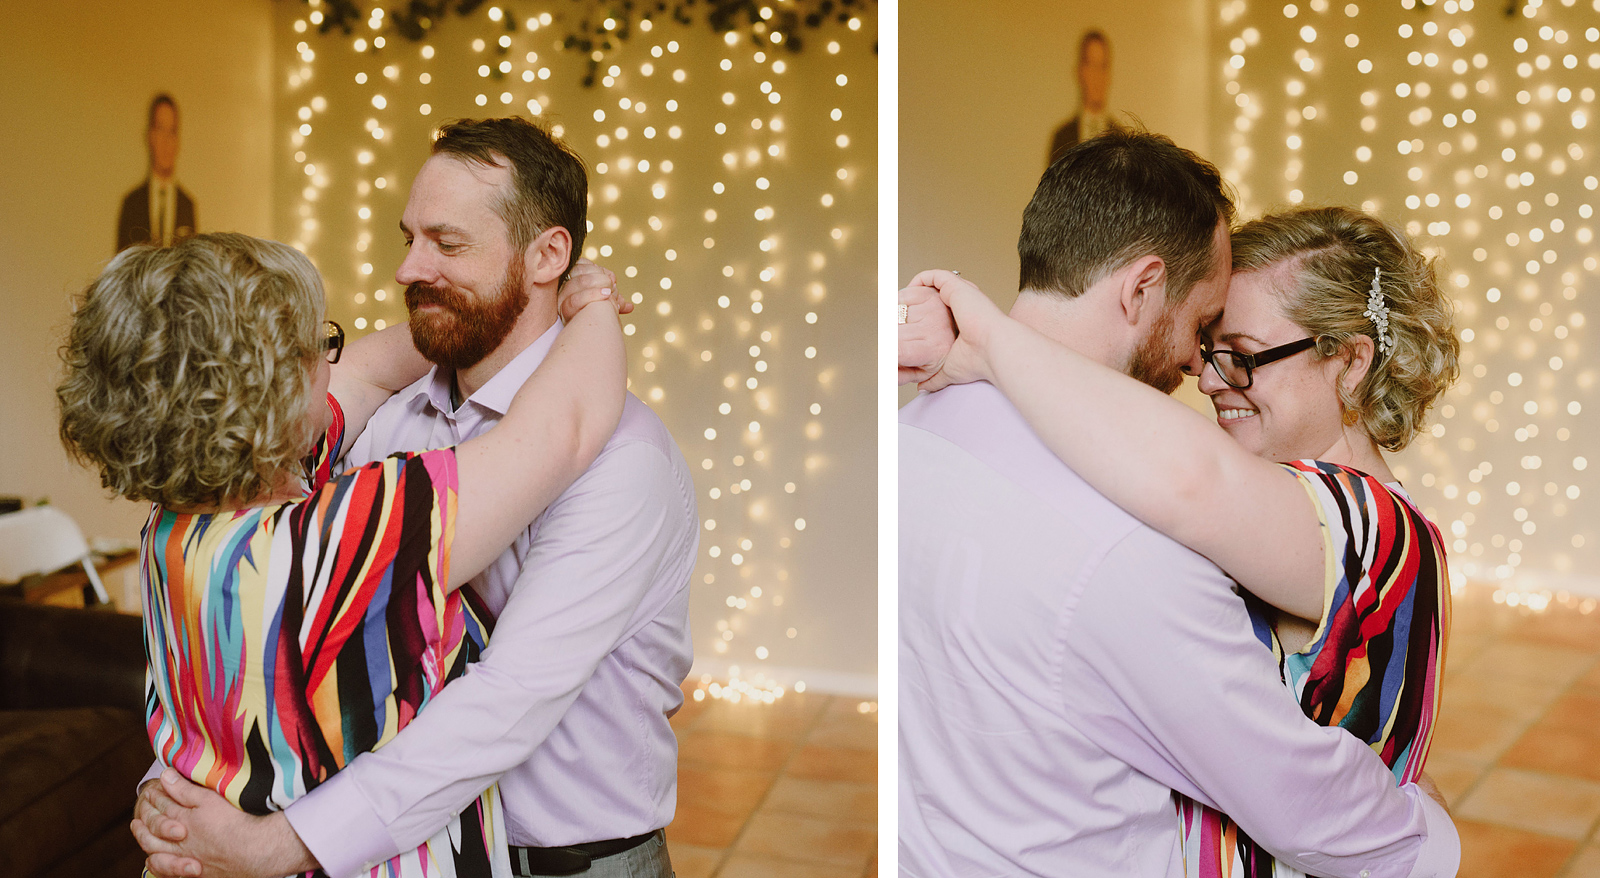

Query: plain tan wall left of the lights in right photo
[899,0,1213,407]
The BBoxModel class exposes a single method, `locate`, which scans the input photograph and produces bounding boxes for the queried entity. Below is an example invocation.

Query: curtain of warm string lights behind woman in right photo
[1218,0,1600,613]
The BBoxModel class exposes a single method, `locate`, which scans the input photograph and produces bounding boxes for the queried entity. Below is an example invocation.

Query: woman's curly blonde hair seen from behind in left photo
[56,233,325,507]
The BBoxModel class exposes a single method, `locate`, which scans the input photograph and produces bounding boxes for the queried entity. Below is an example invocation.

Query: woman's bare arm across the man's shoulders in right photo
[902,272,1325,619]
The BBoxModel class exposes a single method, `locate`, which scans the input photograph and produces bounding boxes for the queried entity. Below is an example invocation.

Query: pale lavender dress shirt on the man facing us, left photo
[286,323,699,878]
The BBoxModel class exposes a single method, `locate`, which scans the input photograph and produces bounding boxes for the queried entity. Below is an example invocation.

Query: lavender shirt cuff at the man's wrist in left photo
[283,771,395,878]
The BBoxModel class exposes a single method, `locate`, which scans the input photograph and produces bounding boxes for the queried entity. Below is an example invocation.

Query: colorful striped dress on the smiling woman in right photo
[1174,461,1450,878]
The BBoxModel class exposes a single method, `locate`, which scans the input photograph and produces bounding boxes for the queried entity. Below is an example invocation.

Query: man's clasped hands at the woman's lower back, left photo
[130,768,317,878]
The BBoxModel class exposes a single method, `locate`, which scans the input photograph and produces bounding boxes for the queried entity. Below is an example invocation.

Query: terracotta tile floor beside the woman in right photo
[1427,585,1600,878]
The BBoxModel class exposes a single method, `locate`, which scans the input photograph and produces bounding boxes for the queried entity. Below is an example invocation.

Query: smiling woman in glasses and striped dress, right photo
[901,208,1459,878]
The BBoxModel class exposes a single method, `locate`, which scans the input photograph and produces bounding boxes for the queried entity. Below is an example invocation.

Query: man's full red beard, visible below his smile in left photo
[405,259,528,371]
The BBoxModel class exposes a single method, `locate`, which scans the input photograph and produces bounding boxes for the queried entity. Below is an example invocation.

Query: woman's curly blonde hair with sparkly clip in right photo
[1234,208,1461,451]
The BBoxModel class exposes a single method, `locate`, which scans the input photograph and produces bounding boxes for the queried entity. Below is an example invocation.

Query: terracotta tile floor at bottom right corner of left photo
[667,691,883,878]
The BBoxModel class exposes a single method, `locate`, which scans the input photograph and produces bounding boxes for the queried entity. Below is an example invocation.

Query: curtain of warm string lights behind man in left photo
[285,0,875,702]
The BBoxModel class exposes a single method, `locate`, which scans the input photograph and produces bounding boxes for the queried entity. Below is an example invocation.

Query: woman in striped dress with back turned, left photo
[56,233,626,876]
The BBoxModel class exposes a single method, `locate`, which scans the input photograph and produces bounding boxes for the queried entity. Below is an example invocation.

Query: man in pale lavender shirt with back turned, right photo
[899,131,1461,878]
